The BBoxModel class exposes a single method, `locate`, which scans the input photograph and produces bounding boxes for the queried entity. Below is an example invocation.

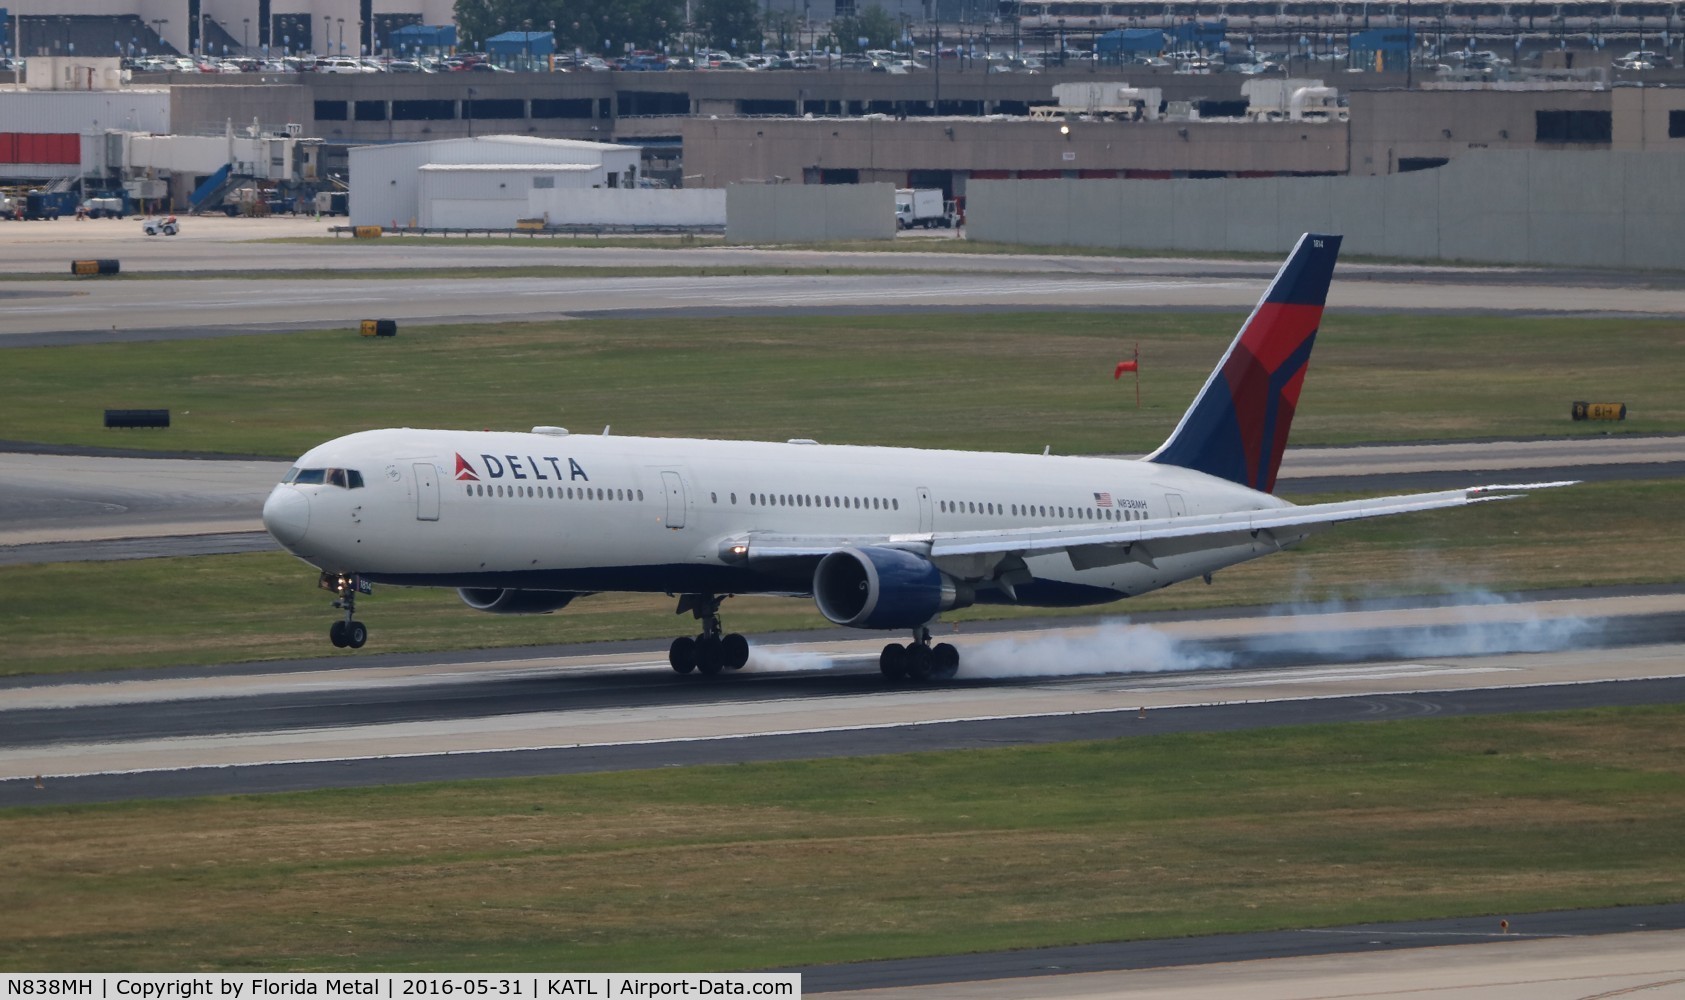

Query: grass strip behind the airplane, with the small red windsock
[0,312,1685,457]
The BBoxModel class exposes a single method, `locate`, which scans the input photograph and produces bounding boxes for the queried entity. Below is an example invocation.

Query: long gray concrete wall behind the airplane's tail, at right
[966,150,1685,270]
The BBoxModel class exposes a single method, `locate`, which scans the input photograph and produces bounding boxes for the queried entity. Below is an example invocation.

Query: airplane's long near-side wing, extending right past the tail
[741,481,1575,580]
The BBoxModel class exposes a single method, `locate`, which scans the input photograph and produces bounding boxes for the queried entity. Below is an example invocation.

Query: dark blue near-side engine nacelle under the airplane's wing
[814,548,972,629]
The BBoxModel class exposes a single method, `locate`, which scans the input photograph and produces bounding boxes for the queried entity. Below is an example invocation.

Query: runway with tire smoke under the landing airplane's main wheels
[0,594,1685,804]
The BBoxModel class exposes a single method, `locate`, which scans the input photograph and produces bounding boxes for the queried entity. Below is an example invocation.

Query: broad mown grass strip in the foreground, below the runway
[0,707,1685,971]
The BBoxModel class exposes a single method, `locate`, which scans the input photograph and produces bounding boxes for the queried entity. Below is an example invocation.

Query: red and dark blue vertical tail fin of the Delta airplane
[1147,233,1340,492]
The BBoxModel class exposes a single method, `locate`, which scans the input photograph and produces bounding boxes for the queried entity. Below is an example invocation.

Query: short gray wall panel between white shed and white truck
[726,184,895,243]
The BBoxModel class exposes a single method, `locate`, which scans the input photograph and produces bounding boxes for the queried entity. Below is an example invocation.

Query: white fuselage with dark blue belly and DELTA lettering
[265,428,1291,605]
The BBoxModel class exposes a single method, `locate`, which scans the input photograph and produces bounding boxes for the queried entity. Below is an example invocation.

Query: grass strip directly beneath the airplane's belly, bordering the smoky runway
[0,479,1685,675]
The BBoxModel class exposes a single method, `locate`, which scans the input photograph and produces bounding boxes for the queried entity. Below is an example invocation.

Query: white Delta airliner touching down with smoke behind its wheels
[263,234,1565,680]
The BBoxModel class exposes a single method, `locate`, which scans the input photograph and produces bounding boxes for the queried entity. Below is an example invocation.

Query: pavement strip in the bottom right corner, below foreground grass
[800,906,1685,1000]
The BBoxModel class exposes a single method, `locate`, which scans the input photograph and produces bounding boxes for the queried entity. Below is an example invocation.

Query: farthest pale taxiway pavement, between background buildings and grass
[0,218,1685,346]
